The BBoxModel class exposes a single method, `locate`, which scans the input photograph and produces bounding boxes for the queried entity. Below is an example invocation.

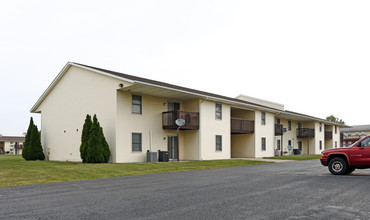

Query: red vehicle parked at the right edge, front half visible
[320,136,370,175]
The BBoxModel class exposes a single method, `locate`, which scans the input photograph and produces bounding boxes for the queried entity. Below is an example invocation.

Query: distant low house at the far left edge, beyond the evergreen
[0,136,25,154]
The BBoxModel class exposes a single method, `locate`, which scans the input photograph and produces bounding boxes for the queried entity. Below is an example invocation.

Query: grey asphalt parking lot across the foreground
[0,160,370,219]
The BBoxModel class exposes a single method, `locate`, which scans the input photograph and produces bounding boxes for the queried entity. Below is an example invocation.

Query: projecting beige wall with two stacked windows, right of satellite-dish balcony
[199,100,231,160]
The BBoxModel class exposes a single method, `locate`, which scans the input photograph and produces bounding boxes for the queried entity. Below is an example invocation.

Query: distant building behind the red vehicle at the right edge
[340,125,370,147]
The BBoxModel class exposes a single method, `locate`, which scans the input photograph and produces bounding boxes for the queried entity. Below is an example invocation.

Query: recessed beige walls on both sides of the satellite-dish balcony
[115,90,199,163]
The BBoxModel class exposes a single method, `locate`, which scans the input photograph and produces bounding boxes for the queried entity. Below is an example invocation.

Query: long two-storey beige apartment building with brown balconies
[31,62,343,163]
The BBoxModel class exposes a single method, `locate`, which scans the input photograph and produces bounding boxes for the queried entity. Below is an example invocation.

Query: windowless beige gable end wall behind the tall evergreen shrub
[37,66,123,161]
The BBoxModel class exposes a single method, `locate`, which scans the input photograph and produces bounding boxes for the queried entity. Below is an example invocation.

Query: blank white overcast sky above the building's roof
[0,0,370,135]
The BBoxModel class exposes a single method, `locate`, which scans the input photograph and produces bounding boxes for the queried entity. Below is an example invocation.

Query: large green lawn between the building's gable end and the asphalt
[0,155,266,187]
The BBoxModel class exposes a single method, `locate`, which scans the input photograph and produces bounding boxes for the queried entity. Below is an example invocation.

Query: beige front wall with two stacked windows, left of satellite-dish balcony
[115,91,168,163]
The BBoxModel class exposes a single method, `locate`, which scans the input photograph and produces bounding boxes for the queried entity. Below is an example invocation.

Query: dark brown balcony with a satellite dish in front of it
[162,111,199,130]
